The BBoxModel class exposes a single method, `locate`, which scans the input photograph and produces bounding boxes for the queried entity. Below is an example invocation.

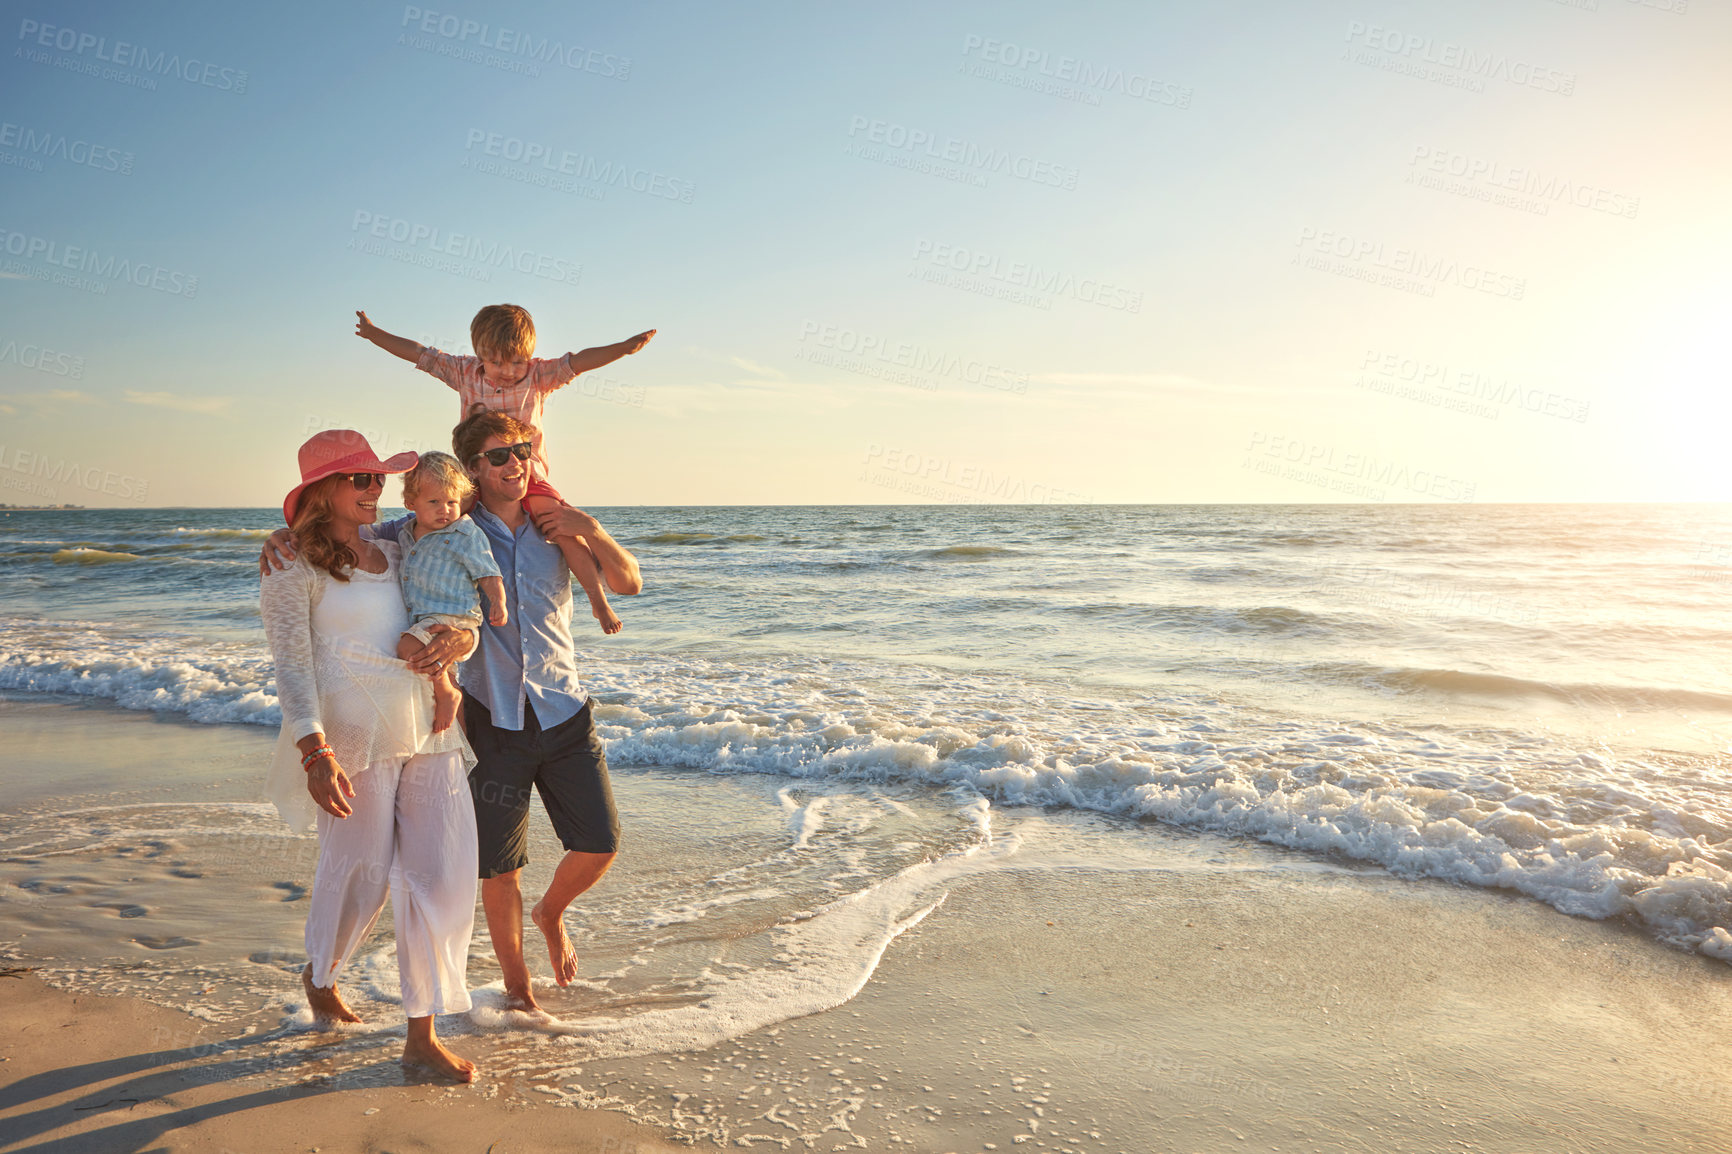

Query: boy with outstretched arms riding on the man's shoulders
[355,305,655,632]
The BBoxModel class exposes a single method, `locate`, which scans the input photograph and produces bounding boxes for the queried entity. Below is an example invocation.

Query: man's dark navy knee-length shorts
[462,693,620,877]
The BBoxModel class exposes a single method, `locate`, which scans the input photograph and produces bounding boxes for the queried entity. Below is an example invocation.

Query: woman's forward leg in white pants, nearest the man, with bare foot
[391,752,476,1081]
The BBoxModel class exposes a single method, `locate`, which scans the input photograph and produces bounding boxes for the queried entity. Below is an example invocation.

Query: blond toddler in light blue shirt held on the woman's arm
[397,452,506,733]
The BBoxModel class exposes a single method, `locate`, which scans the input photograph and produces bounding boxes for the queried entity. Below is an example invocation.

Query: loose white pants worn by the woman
[307,752,476,1017]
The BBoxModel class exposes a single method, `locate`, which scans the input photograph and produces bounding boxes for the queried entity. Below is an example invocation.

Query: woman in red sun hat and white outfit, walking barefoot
[258,430,476,1081]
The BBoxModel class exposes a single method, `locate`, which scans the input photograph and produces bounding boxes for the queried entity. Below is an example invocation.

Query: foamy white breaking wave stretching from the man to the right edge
[581,658,1732,960]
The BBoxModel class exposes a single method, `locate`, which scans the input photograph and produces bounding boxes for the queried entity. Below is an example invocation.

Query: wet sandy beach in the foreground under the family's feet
[10,702,1732,1154]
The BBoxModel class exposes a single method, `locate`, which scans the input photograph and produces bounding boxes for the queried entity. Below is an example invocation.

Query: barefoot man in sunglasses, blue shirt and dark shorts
[452,412,643,1012]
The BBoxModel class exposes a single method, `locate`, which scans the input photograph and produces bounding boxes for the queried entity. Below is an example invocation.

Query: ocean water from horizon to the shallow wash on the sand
[0,495,1732,1108]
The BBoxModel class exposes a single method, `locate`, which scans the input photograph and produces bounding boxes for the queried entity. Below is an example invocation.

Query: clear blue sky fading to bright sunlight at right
[0,0,1732,506]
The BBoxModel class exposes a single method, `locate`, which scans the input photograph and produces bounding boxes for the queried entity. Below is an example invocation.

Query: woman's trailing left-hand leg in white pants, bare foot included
[301,762,397,1022]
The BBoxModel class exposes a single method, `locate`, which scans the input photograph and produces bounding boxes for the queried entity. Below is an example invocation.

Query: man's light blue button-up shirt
[374,504,589,729]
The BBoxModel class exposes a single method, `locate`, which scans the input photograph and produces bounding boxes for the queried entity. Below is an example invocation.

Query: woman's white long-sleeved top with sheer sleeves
[258,541,475,830]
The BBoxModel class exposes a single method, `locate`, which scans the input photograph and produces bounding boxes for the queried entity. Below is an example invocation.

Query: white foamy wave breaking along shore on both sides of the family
[10,622,1732,962]
